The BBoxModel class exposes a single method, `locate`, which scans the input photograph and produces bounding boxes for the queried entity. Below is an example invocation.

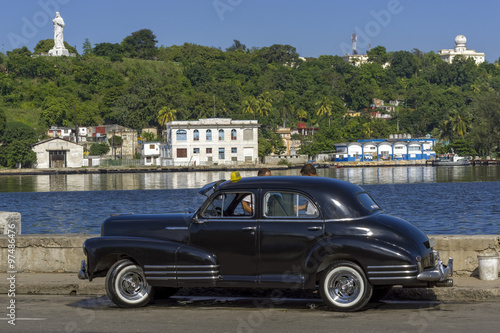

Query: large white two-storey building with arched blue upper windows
[160,118,260,166]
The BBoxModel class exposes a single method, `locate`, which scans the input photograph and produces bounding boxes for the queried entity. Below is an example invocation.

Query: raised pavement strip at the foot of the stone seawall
[0,273,500,302]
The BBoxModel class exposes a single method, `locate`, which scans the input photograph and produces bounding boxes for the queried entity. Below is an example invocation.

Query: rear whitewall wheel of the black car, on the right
[319,261,372,311]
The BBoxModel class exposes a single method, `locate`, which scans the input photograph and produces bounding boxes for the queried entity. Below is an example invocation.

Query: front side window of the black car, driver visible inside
[201,192,255,218]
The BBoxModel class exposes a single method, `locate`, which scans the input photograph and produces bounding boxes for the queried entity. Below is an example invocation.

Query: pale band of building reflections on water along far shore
[0,166,500,192]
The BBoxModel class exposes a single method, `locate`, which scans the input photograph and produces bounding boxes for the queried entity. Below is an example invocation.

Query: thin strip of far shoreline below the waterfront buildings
[0,160,431,176]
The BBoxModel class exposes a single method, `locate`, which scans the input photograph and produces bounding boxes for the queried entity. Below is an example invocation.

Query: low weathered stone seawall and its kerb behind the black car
[0,234,500,302]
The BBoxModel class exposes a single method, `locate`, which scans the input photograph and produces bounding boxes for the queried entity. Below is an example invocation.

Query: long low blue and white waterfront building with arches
[335,137,436,162]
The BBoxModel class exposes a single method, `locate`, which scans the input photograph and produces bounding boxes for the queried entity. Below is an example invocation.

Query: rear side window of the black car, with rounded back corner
[263,192,319,218]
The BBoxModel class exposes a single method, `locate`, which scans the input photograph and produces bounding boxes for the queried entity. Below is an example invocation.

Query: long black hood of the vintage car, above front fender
[101,213,193,242]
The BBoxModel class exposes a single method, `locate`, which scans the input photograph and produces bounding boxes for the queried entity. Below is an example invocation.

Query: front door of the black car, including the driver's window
[190,191,257,285]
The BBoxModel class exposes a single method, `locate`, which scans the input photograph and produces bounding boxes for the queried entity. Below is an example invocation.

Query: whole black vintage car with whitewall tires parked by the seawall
[79,176,453,311]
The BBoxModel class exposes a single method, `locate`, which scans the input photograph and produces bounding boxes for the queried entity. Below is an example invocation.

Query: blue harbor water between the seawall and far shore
[0,166,500,235]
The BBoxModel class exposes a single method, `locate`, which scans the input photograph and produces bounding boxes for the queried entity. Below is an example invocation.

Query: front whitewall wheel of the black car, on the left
[106,259,153,308]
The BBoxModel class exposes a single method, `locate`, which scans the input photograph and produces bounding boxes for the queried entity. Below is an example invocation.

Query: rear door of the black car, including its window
[258,191,324,288]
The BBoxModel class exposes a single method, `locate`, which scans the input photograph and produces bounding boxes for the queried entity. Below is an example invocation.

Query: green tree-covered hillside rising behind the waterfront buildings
[0,29,500,166]
